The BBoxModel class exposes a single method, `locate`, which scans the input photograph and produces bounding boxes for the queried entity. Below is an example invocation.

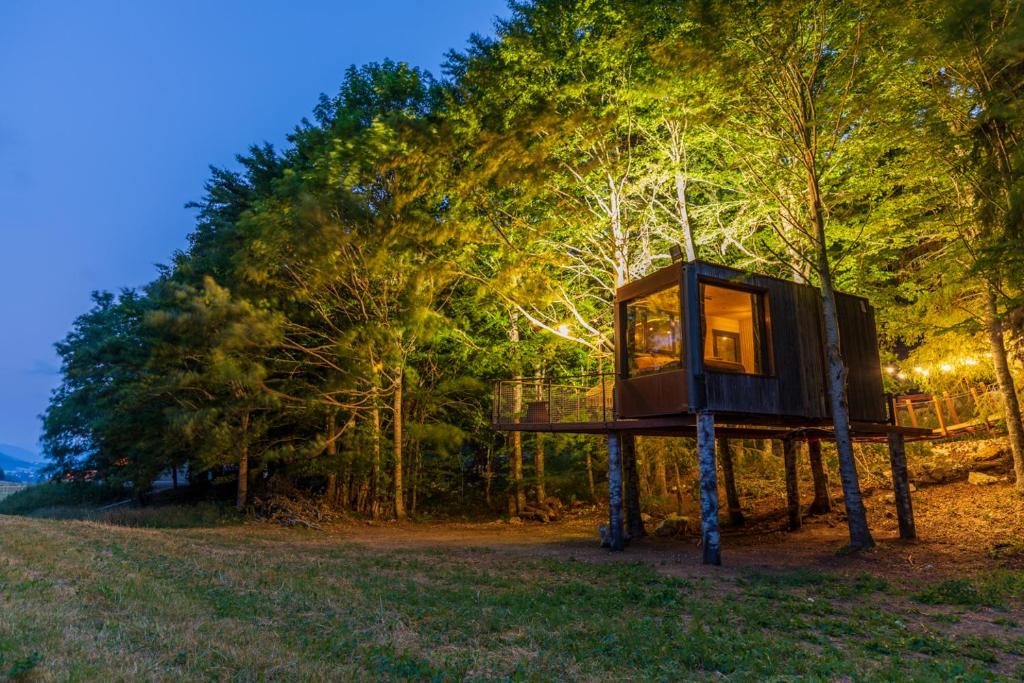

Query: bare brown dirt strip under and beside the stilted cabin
[299,482,1024,588]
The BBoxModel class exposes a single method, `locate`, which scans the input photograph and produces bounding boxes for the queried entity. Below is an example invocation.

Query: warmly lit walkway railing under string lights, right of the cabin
[893,385,1002,435]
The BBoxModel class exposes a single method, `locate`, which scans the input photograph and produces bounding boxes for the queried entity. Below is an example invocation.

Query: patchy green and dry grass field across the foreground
[0,516,1024,681]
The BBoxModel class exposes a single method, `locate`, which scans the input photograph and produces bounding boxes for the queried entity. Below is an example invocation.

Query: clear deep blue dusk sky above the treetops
[0,0,507,458]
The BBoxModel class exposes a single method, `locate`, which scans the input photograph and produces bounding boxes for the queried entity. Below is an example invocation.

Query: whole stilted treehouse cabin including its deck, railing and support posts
[493,261,930,563]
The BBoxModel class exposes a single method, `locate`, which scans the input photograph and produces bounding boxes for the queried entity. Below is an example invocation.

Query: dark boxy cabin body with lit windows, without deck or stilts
[614,261,890,424]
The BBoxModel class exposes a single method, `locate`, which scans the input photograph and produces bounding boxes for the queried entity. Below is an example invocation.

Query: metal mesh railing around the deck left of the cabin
[494,375,614,425]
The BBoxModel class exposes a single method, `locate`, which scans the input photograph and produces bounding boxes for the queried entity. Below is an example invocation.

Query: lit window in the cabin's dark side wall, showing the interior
[700,285,767,375]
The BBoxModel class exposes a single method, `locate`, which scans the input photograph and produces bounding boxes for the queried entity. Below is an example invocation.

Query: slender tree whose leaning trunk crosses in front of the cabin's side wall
[711,2,925,548]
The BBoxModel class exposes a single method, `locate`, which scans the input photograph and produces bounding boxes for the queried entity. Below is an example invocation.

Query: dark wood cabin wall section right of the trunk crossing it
[836,294,889,422]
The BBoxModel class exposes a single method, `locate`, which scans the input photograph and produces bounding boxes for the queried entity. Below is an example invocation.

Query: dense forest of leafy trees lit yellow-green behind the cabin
[43,0,1024,519]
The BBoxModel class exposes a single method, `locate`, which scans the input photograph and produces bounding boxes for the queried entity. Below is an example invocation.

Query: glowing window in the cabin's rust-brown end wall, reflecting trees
[626,285,683,377]
